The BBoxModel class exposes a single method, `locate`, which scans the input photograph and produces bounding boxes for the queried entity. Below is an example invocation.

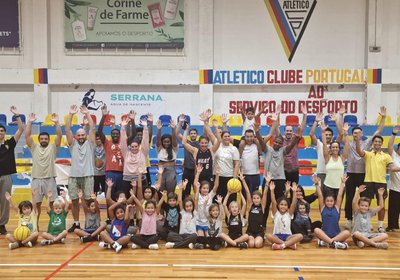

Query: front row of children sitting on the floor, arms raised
[6,166,388,252]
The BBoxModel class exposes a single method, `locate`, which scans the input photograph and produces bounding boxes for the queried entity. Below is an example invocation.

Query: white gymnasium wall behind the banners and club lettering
[0,0,400,124]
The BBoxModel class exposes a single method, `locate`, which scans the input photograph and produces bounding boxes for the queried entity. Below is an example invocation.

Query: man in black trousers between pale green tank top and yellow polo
[344,106,386,229]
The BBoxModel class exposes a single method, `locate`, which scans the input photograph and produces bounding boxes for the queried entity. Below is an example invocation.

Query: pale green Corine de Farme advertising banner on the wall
[64,0,184,49]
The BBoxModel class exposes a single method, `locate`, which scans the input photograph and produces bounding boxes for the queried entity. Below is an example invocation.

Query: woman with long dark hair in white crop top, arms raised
[156,120,178,193]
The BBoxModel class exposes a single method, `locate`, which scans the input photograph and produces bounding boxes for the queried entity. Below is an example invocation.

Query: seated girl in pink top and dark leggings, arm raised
[131,192,159,250]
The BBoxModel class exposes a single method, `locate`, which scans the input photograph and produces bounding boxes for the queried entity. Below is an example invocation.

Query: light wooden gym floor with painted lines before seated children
[0,209,400,279]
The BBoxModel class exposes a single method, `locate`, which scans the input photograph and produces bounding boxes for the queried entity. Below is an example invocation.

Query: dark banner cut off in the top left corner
[0,0,19,48]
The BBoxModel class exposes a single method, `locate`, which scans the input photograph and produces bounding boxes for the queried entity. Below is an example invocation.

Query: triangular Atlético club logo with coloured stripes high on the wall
[264,0,317,62]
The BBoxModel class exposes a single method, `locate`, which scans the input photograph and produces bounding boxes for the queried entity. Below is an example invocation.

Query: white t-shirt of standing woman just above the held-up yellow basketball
[214,144,240,177]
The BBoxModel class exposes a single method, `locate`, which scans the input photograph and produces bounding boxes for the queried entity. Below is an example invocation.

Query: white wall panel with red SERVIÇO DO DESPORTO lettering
[214,85,365,124]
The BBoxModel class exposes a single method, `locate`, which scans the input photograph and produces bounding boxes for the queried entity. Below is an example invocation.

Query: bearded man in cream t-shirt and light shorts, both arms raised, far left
[25,113,62,220]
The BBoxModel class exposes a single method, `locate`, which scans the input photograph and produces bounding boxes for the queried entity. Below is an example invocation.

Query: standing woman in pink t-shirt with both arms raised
[121,119,149,198]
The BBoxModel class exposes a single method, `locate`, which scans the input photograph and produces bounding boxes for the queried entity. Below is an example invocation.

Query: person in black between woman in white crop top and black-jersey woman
[176,114,200,198]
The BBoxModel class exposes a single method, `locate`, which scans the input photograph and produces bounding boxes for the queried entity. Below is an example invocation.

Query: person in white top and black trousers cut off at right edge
[386,127,400,231]
